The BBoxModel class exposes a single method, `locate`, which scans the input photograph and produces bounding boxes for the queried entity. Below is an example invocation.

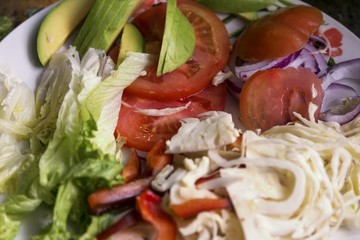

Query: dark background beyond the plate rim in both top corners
[0,0,360,37]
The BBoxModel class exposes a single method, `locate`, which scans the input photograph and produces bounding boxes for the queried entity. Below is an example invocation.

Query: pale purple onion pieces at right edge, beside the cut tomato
[320,58,360,124]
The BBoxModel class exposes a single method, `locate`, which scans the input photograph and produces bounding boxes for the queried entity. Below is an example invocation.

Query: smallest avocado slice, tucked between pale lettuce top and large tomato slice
[117,23,144,66]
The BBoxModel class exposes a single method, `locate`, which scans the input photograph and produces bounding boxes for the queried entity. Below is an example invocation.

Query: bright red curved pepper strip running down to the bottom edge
[136,189,177,240]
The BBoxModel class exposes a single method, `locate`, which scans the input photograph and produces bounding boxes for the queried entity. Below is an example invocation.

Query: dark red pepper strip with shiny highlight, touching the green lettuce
[88,177,152,214]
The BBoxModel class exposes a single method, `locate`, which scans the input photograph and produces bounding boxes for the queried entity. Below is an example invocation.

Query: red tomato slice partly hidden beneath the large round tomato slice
[115,84,226,152]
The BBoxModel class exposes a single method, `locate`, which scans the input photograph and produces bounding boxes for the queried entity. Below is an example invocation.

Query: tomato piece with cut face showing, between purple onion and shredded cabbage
[240,68,324,131]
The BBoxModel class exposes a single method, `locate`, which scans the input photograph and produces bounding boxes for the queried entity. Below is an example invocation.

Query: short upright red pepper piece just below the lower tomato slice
[145,139,173,176]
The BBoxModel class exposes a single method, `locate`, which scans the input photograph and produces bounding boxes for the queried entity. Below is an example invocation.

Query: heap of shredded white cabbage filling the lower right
[168,109,360,239]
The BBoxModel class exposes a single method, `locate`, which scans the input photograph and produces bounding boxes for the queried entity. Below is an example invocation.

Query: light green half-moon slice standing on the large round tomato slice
[156,0,195,76]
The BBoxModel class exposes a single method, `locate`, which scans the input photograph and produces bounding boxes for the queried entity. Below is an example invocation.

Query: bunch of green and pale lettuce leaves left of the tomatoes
[0,48,154,239]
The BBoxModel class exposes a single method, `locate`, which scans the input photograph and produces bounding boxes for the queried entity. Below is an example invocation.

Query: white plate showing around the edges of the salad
[0,0,360,240]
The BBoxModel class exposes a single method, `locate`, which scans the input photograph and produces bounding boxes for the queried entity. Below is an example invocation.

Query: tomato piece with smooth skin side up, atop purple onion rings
[235,6,323,61]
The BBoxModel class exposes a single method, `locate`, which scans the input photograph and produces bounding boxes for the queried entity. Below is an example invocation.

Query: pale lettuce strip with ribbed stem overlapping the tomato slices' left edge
[85,52,156,153]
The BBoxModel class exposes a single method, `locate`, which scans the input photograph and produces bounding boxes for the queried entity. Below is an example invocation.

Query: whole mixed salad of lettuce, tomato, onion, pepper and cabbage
[0,0,360,239]
